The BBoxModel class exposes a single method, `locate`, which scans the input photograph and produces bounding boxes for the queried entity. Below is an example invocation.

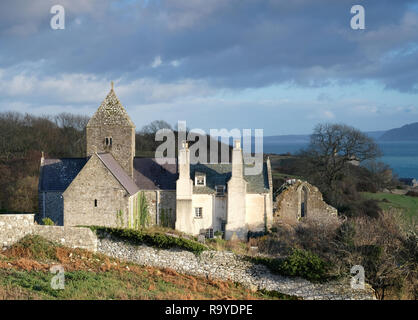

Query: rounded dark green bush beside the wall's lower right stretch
[250,249,328,282]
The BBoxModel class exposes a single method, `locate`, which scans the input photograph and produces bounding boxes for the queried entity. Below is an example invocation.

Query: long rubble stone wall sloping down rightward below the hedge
[98,237,375,300]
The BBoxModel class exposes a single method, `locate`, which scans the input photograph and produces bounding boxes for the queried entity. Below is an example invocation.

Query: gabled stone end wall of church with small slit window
[63,155,129,227]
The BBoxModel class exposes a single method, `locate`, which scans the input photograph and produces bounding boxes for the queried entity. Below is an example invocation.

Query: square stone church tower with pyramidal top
[86,82,135,177]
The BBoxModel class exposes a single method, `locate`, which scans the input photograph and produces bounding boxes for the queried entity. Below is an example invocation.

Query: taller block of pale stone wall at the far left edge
[0,214,35,248]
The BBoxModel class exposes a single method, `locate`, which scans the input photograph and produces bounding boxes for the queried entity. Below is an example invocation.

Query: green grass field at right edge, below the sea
[362,192,418,219]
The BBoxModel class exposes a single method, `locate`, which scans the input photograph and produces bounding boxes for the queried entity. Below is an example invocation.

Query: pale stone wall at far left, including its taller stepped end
[0,214,97,251]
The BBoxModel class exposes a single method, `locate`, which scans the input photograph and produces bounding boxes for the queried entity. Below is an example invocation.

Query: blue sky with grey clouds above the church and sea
[0,0,418,135]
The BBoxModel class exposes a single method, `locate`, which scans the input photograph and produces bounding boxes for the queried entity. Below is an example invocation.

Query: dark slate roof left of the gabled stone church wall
[39,158,89,192]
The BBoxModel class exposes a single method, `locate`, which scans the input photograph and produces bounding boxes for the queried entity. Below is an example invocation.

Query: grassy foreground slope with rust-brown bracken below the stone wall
[0,236,284,299]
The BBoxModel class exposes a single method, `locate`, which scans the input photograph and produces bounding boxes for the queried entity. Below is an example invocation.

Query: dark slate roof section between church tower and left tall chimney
[134,158,178,190]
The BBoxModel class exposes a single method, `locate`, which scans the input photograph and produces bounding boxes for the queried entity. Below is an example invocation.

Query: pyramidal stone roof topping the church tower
[87,81,135,128]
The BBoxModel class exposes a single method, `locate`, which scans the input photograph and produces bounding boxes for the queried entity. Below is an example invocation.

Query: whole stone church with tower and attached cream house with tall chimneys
[38,84,273,239]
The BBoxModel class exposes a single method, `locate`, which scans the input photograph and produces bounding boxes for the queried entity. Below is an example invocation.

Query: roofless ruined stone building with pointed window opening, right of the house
[274,179,338,225]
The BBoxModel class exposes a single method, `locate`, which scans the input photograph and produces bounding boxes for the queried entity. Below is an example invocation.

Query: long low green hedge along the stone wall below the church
[89,226,208,254]
